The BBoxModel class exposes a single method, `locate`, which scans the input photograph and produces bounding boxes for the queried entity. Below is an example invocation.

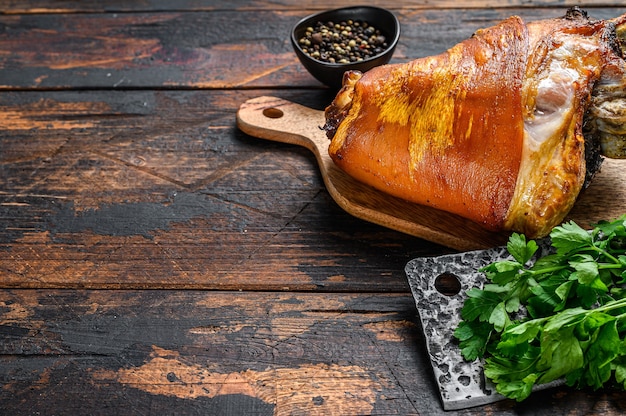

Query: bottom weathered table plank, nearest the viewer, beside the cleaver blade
[0,290,625,416]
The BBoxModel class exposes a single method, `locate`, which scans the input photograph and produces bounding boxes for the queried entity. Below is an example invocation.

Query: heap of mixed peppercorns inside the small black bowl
[298,20,388,64]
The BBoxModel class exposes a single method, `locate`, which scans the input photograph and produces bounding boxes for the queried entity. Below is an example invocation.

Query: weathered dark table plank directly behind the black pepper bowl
[0,6,626,90]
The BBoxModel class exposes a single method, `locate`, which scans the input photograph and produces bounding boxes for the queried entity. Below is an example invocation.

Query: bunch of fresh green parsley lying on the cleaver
[454,215,626,401]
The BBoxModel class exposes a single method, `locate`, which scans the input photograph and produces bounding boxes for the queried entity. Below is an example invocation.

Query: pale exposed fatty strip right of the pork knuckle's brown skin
[506,33,599,234]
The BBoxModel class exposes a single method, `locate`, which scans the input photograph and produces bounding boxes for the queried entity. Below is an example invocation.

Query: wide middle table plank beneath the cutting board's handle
[0,90,450,291]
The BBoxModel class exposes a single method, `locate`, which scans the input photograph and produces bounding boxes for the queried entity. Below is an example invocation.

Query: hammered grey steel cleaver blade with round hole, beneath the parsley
[405,242,563,410]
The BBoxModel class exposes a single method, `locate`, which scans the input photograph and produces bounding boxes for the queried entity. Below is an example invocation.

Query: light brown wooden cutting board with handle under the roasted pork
[237,97,626,251]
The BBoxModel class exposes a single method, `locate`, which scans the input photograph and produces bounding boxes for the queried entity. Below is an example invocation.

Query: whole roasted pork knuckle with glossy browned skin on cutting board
[324,8,626,238]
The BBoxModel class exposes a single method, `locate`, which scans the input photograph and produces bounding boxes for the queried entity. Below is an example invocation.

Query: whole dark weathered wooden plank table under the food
[0,0,626,416]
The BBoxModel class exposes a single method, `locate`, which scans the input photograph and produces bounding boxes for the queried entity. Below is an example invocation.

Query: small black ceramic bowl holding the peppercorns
[291,6,400,90]
